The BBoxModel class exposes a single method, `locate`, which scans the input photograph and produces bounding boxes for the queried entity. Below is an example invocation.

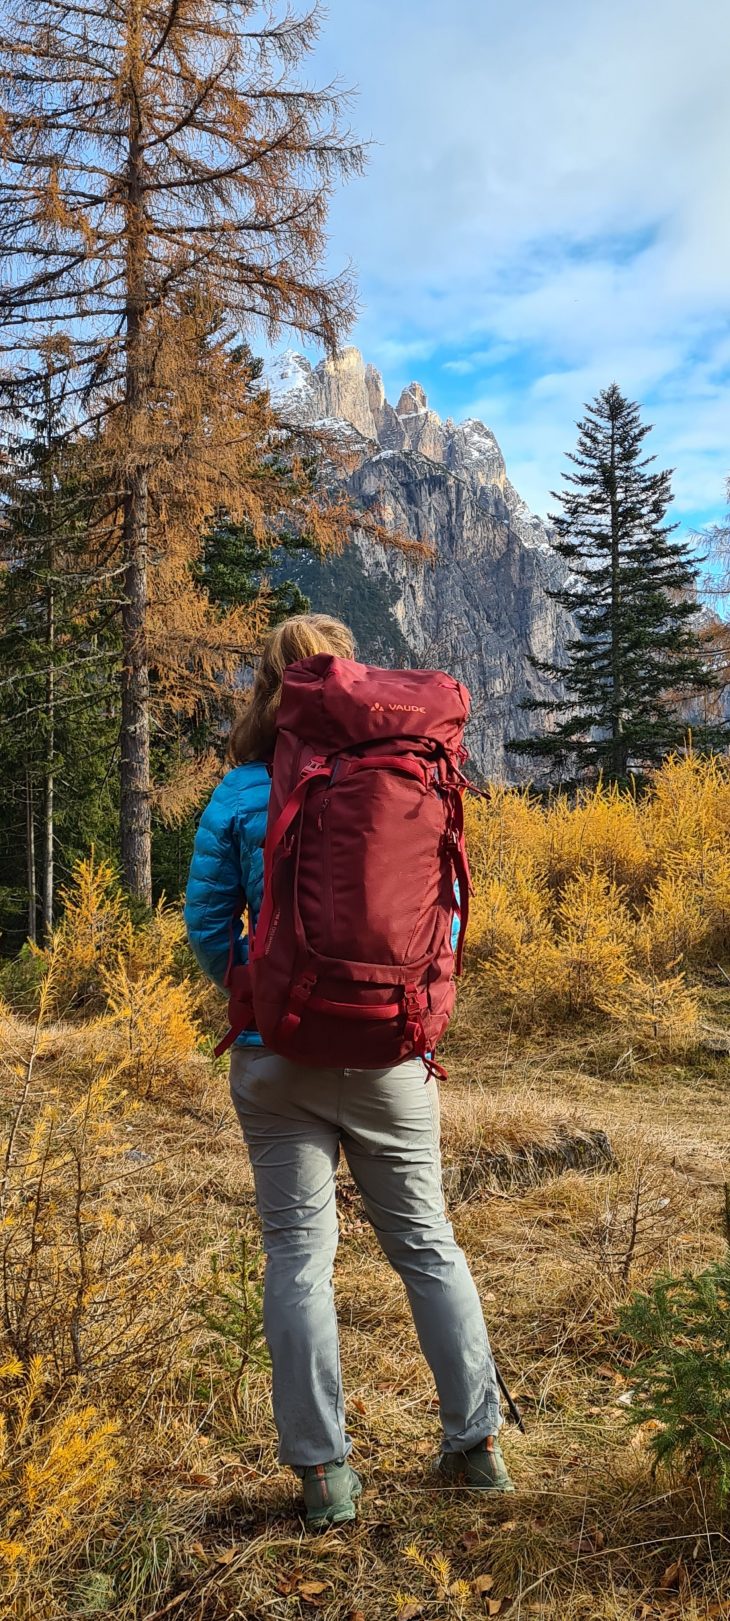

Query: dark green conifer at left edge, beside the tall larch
[0,364,118,948]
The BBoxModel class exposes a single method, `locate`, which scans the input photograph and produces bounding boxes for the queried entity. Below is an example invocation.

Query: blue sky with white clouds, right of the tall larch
[288,0,730,541]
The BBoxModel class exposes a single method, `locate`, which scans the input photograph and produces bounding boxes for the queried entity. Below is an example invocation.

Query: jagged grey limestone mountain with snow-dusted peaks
[266,349,569,780]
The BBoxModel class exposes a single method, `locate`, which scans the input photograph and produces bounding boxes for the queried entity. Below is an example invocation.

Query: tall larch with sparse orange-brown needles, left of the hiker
[0,0,362,901]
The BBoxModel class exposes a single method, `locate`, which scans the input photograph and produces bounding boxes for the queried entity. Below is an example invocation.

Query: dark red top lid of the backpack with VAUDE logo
[276,653,470,754]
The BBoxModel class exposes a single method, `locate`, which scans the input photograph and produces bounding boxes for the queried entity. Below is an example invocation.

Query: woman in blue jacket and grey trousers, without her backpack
[185,614,514,1527]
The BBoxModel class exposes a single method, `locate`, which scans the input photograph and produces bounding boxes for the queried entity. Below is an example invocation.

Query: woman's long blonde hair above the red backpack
[229,613,355,765]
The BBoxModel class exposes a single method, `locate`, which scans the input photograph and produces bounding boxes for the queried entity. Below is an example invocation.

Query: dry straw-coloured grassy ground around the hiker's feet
[5,972,730,1621]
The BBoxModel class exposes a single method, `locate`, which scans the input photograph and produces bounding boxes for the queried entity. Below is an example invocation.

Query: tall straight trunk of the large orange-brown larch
[120,0,152,906]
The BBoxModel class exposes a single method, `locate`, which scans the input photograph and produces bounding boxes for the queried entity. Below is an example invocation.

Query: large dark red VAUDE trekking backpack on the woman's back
[219,653,469,1068]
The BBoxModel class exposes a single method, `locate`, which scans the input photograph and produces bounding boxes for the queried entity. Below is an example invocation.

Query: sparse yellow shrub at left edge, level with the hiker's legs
[0,1029,188,1394]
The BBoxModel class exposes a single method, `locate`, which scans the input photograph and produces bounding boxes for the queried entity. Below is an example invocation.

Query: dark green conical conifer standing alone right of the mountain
[509,384,727,781]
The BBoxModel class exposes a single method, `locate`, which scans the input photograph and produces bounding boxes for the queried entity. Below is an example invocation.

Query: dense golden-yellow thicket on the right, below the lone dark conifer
[467,754,730,1041]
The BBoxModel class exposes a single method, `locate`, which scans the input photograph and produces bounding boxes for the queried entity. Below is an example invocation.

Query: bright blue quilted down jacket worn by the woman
[185,762,271,1047]
